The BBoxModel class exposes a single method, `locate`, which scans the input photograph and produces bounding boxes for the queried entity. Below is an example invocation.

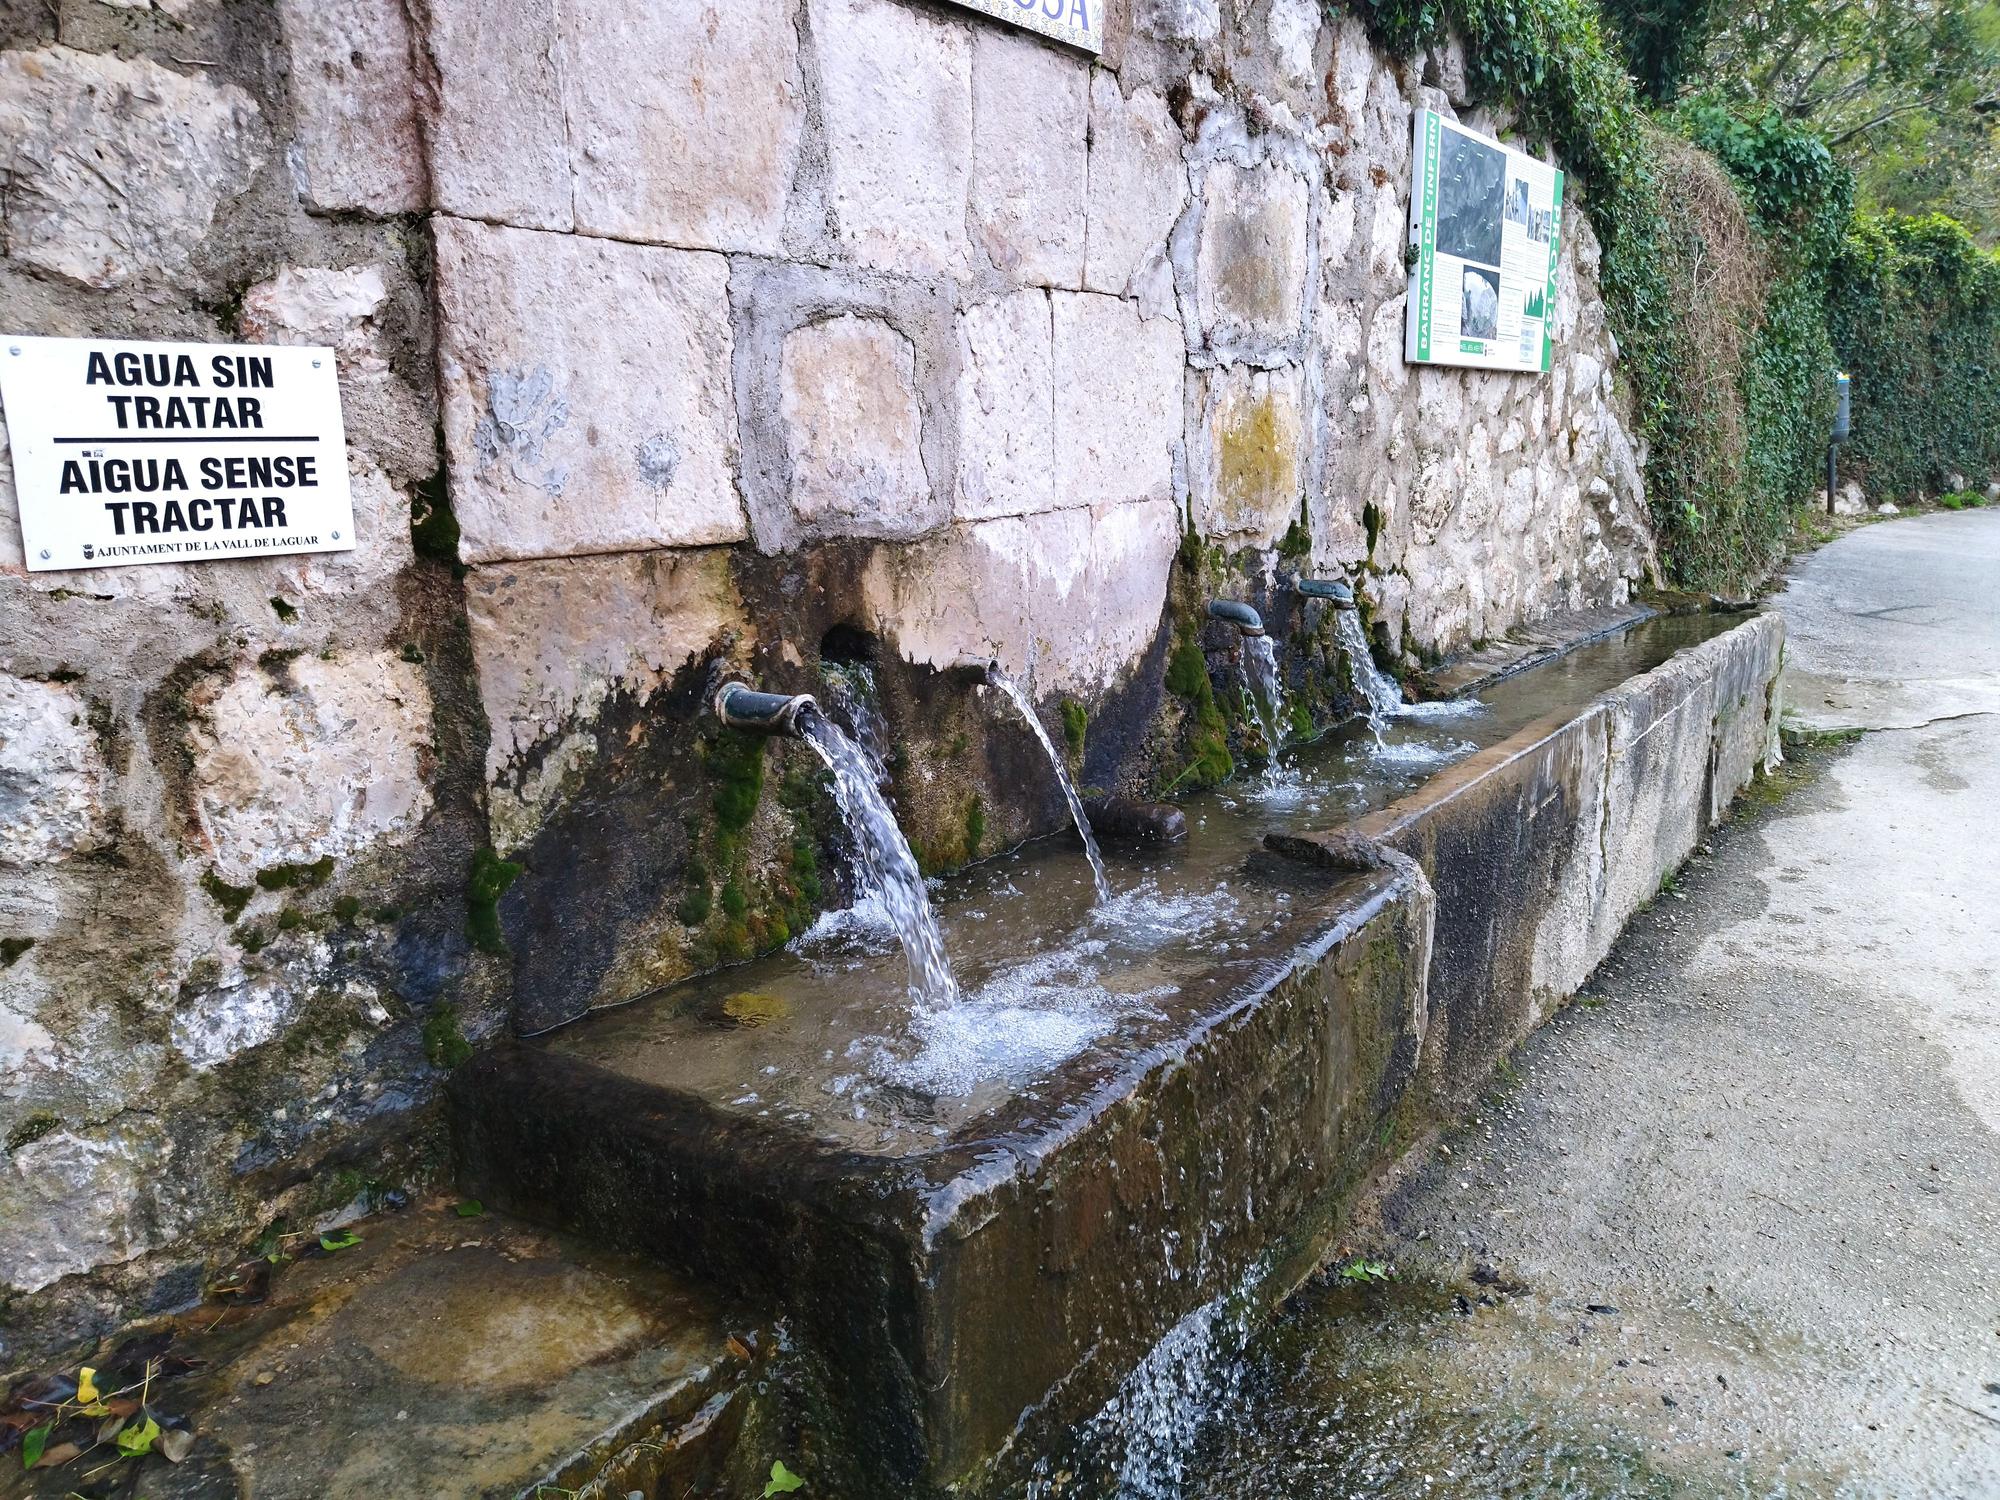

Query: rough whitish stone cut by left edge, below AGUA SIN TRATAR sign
[0,672,110,868]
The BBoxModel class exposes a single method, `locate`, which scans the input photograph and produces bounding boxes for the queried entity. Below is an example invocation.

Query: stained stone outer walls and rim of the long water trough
[454,616,1782,1496]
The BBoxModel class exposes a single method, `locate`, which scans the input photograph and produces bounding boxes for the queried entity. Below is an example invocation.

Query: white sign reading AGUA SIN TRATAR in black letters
[0,336,354,572]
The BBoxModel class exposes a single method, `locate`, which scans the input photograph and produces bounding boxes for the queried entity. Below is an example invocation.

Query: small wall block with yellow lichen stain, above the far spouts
[1194,364,1306,546]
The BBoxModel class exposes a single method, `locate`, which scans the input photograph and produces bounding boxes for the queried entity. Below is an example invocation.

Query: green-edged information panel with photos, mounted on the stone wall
[1404,110,1562,370]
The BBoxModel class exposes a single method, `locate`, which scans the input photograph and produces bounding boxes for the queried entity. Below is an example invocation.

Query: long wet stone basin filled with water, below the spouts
[452,616,1782,1496]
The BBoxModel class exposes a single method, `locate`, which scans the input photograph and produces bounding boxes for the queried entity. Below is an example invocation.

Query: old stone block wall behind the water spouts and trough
[0,0,1650,1364]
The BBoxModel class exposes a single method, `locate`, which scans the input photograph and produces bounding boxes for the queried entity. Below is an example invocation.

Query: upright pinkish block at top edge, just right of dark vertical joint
[412,0,576,230]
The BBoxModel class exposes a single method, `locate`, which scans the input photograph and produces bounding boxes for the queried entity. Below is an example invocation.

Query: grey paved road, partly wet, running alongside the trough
[1186,512,2000,1500]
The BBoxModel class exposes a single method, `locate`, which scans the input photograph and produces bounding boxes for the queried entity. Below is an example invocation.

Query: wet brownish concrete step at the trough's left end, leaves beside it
[0,1202,772,1500]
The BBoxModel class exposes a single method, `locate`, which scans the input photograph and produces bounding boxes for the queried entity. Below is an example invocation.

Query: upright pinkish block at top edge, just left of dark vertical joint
[280,0,428,216]
